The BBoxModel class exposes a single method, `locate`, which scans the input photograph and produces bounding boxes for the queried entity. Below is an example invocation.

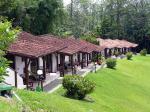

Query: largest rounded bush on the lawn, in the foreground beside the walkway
[63,75,95,100]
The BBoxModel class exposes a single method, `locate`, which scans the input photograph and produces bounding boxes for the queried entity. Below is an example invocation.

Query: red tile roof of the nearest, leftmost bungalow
[8,32,66,57]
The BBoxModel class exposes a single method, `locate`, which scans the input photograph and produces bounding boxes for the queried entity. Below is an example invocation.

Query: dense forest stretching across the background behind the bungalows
[0,0,150,50]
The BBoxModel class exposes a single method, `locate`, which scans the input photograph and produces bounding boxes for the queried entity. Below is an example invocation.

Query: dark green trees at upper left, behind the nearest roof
[0,0,65,35]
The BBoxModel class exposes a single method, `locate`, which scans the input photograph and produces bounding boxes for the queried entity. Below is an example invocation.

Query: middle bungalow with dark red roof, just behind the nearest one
[59,37,103,74]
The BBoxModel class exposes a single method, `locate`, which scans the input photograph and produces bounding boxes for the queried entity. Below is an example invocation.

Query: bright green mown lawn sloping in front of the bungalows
[0,56,150,112]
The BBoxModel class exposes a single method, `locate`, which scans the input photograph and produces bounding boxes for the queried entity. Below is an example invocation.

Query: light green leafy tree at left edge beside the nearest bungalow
[0,20,19,82]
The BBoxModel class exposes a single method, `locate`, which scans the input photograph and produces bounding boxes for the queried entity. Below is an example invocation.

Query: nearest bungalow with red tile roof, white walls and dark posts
[6,32,67,88]
